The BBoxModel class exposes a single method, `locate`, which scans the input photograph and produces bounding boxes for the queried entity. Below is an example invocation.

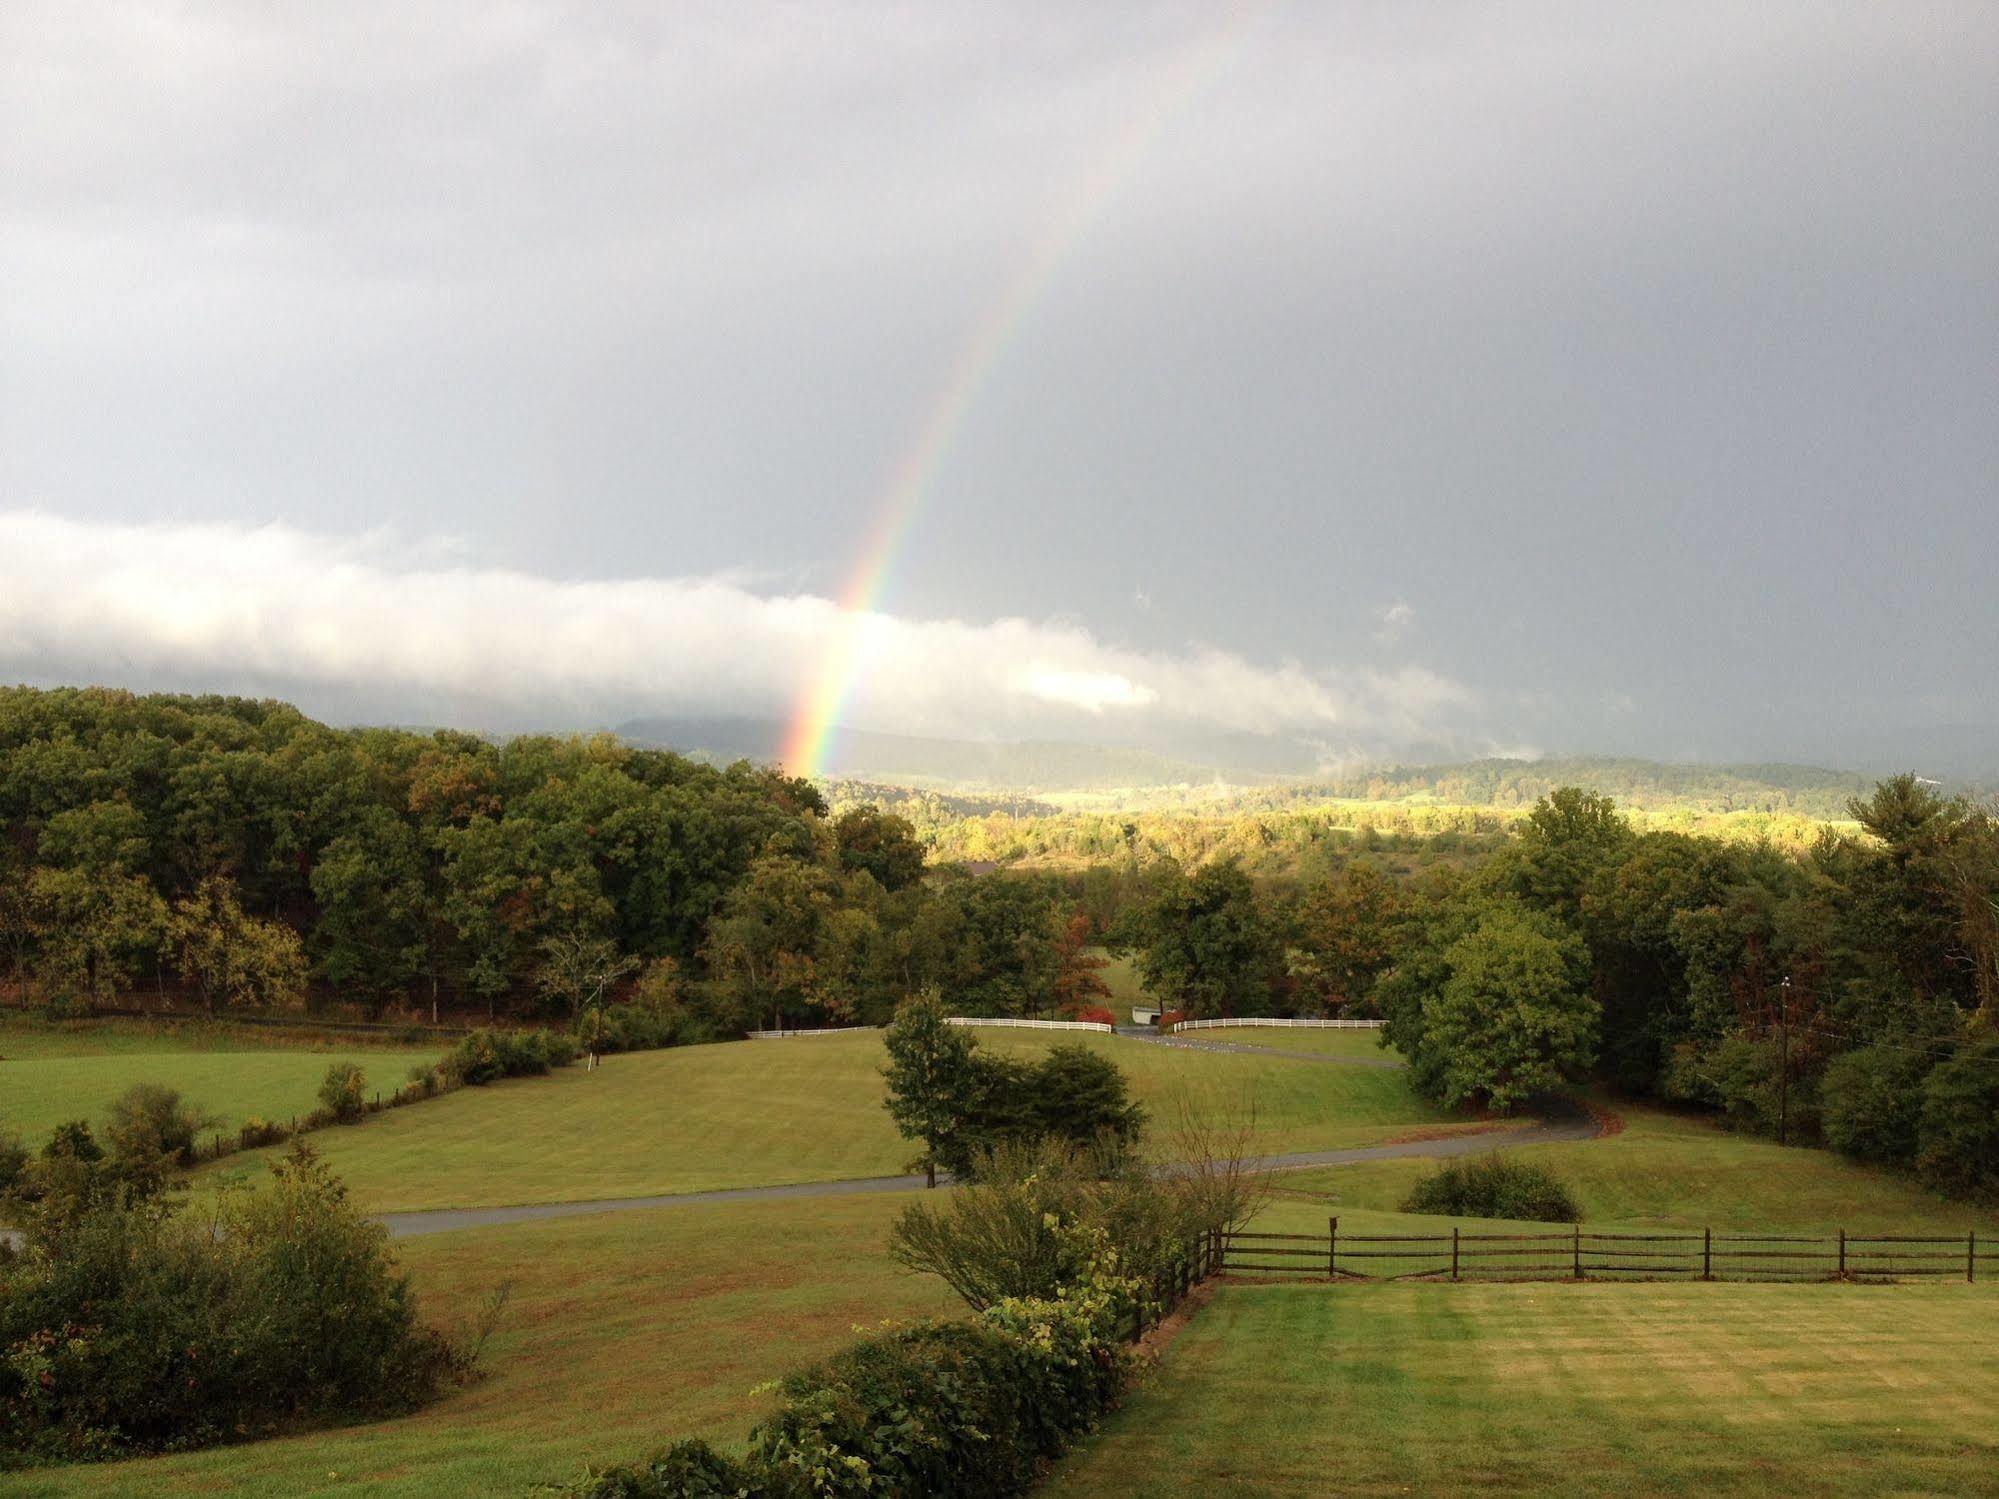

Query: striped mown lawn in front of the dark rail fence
[1045,1285,1999,1499]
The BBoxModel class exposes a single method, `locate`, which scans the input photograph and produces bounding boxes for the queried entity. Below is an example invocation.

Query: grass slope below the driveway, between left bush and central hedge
[0,1197,960,1499]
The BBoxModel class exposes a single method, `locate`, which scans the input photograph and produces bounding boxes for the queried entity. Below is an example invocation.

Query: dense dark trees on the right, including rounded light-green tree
[1109,775,1999,1193]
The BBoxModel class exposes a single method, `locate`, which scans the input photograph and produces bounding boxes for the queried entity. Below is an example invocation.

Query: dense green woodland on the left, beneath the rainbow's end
[0,688,1095,1033]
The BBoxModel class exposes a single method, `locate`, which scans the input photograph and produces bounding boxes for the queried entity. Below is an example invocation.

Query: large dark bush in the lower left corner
[0,1143,460,1463]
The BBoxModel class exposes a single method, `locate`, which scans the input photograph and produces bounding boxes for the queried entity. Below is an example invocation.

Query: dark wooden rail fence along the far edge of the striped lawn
[1207,1217,1999,1281]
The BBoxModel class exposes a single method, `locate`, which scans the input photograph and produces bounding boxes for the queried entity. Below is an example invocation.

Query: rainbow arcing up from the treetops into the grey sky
[780,0,1269,775]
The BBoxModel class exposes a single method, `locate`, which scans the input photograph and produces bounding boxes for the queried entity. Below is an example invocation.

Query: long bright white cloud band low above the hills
[0,512,1475,746]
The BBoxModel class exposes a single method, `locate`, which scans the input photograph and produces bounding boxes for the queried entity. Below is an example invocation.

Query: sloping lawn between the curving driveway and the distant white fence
[198,1029,1447,1211]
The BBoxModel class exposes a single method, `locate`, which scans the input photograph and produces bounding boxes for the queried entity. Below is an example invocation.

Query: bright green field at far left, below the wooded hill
[0,1021,444,1145]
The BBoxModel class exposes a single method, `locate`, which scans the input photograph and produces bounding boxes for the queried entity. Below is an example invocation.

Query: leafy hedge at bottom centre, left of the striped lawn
[572,1277,1129,1499]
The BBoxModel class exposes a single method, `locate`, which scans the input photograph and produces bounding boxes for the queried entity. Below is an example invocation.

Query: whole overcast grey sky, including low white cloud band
[0,0,1999,763]
